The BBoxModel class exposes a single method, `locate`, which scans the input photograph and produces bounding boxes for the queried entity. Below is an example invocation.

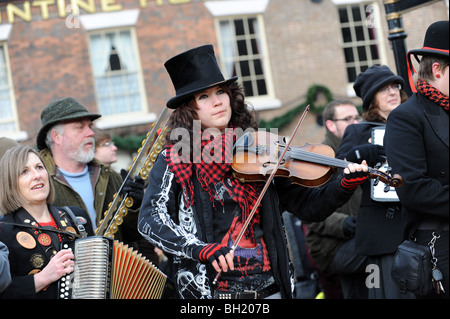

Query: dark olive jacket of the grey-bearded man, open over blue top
[41,148,140,243]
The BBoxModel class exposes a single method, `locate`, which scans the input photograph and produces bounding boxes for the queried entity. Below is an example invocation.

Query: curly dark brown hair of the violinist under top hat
[166,83,258,143]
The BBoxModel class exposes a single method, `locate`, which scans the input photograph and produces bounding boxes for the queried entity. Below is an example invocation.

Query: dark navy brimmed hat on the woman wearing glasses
[353,65,405,112]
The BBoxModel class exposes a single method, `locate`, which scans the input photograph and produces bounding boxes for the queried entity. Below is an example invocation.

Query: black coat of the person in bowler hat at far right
[384,94,449,238]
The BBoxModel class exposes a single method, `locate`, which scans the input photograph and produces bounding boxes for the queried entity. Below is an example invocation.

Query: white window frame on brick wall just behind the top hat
[204,0,281,111]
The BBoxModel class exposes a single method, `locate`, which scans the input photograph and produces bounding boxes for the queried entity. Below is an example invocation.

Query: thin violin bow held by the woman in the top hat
[213,104,310,285]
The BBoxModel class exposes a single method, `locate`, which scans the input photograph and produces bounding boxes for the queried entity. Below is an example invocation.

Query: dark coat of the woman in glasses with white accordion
[336,122,402,256]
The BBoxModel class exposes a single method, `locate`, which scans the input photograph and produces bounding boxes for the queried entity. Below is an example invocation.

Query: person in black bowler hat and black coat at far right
[384,20,450,298]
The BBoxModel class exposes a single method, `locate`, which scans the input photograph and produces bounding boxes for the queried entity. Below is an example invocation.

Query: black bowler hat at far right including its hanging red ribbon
[406,20,449,92]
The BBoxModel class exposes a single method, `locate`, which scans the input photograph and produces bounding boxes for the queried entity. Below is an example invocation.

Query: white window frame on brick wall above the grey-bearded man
[80,9,153,129]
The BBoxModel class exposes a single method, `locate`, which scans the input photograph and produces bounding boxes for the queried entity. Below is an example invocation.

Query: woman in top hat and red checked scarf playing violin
[138,45,368,299]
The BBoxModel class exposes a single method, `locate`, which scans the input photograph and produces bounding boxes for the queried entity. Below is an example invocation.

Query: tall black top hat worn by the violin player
[164,44,238,109]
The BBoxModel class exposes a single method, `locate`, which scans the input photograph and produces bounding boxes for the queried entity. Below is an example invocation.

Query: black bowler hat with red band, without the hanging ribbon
[409,20,449,58]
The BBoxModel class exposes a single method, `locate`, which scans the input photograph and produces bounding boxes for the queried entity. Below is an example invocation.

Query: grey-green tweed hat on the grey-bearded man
[36,97,101,150]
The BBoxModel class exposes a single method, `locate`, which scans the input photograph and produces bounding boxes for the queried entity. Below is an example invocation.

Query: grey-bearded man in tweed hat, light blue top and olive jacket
[36,97,144,243]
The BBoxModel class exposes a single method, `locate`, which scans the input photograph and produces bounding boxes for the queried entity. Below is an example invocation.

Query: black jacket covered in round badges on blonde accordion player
[0,206,93,299]
